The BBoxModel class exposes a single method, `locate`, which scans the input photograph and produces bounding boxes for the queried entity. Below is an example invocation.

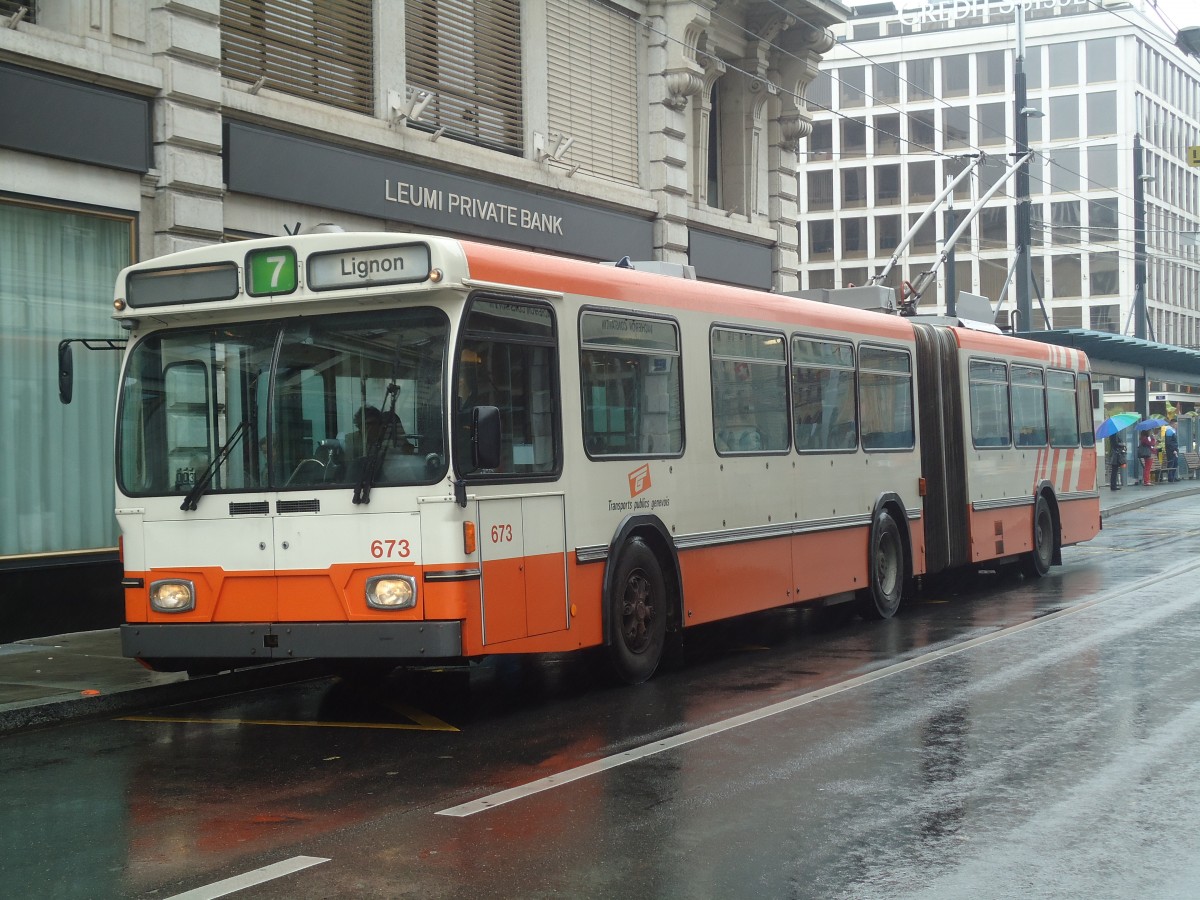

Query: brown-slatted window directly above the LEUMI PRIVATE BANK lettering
[404,0,524,154]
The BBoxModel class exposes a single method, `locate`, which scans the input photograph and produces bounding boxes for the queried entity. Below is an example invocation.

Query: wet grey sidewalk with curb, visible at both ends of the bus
[0,479,1200,736]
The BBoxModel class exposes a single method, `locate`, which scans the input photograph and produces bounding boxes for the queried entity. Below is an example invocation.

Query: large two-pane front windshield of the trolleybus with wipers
[118,308,449,500]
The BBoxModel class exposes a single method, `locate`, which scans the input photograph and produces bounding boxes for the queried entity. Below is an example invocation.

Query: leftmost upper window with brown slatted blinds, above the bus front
[221,0,374,115]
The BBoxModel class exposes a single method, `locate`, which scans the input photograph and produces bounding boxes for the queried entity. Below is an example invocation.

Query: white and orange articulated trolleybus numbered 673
[115,233,1099,682]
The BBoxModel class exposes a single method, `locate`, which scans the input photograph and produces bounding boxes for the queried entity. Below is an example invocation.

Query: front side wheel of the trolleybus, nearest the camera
[608,538,667,684]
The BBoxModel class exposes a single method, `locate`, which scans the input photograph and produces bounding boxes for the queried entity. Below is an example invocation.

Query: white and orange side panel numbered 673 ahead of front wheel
[479,494,569,644]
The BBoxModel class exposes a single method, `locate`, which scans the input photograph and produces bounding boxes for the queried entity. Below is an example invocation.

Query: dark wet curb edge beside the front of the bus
[0,660,329,736]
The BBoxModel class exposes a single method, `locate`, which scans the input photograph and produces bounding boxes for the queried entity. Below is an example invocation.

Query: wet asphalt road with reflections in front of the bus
[0,498,1200,898]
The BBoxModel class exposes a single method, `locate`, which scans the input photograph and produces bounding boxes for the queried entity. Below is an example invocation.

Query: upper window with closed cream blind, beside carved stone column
[546,0,638,185]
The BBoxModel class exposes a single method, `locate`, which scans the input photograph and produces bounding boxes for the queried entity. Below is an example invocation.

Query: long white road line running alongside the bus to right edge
[437,562,1200,817]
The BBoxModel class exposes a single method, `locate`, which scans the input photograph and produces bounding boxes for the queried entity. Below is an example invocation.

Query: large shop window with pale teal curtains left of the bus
[0,202,133,558]
